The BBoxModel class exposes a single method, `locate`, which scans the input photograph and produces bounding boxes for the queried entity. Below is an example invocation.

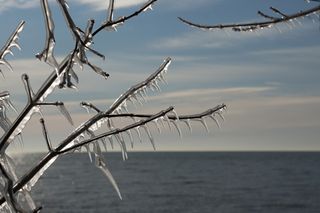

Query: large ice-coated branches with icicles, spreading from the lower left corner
[0,0,225,212]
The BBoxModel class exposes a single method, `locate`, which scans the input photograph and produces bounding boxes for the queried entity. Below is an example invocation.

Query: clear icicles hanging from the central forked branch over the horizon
[50,58,226,201]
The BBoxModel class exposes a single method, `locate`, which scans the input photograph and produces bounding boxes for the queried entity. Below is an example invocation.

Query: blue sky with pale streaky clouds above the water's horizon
[0,0,320,152]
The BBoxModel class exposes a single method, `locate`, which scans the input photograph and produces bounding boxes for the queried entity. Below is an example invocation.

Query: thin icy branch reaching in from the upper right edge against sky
[179,6,320,32]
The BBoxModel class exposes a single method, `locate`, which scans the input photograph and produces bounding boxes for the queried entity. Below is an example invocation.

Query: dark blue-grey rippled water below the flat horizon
[13,152,320,213]
